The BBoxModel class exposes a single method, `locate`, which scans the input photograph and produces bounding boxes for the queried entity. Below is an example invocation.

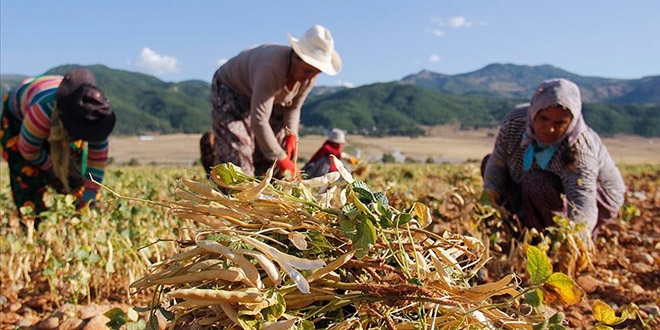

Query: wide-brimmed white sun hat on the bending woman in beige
[287,25,341,76]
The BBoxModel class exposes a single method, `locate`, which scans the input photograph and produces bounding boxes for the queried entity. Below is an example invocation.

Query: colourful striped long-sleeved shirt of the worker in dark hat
[8,76,109,192]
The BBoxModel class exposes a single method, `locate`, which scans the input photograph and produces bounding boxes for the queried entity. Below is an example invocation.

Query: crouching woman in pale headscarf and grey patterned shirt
[482,79,626,239]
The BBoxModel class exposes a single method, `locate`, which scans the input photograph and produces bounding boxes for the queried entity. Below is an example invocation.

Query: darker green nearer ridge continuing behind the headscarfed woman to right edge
[302,82,660,137]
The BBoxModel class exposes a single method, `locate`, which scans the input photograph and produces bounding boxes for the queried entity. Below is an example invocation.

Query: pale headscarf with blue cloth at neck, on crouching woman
[522,78,587,170]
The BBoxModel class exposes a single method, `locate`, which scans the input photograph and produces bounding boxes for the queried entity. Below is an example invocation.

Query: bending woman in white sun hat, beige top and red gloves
[200,25,342,177]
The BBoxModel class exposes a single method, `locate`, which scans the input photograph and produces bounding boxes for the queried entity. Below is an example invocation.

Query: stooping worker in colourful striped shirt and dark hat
[0,68,116,227]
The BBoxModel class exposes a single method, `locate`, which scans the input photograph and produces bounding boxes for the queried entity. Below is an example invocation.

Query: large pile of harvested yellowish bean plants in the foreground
[131,160,564,329]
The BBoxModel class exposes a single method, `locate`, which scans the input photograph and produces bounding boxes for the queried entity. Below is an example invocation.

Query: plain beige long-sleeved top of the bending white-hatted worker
[214,45,316,160]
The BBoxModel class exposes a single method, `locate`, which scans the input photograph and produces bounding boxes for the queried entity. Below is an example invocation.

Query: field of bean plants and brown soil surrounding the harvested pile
[0,133,660,329]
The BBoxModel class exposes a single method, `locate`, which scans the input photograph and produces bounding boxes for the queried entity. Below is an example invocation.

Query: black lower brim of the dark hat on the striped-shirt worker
[60,112,117,142]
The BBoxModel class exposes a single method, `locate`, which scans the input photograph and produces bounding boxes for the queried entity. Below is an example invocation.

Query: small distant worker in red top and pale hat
[302,128,346,178]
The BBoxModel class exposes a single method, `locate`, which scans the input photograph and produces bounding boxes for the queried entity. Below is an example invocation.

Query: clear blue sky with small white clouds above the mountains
[0,0,660,86]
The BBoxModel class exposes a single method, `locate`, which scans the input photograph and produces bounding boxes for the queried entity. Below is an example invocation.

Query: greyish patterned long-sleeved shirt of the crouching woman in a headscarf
[484,106,626,229]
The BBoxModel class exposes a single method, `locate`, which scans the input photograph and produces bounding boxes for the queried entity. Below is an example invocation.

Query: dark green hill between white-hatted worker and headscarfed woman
[301,82,516,136]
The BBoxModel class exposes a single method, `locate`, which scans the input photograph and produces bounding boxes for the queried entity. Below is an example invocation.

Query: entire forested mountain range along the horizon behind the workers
[0,64,660,137]
